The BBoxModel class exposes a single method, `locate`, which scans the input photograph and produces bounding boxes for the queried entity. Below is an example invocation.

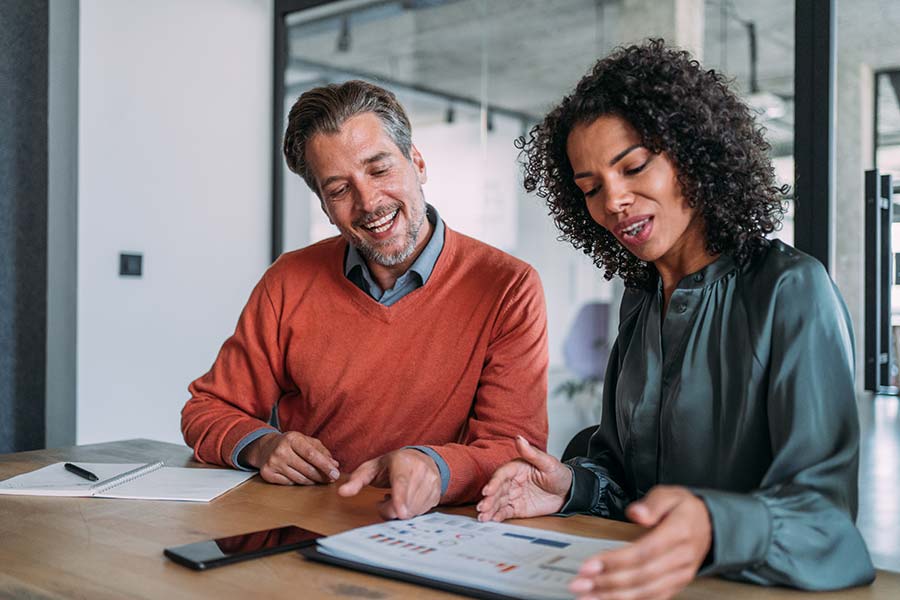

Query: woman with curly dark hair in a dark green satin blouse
[478,40,874,598]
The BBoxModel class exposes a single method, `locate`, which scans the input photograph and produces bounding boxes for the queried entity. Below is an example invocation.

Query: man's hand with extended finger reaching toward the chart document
[338,448,441,519]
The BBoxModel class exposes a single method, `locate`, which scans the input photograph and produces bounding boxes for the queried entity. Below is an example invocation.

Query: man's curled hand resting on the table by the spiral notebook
[238,431,341,485]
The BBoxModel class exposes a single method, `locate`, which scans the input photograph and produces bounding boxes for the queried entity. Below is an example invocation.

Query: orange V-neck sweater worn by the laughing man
[181,228,548,503]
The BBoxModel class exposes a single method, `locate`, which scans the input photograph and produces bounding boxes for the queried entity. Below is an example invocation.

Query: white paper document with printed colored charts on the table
[318,513,625,600]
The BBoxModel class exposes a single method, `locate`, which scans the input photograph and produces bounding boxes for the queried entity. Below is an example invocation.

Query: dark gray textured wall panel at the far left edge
[0,0,48,452]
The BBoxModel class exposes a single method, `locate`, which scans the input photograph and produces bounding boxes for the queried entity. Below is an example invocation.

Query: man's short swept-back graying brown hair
[284,80,412,194]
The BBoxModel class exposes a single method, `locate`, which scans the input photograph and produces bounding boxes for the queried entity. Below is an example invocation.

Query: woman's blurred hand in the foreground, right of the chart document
[569,486,712,600]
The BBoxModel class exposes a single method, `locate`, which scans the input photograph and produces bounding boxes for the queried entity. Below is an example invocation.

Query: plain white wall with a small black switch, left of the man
[77,0,273,444]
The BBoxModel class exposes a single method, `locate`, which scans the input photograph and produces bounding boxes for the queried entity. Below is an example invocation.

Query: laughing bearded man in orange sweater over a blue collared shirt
[182,81,547,518]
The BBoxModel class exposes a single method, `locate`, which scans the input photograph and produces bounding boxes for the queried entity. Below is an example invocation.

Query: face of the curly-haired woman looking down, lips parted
[566,115,706,273]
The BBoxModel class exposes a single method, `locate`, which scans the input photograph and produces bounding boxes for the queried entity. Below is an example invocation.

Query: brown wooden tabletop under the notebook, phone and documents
[0,440,900,600]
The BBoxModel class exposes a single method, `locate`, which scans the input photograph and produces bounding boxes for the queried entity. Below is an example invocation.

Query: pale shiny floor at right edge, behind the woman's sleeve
[857,395,900,571]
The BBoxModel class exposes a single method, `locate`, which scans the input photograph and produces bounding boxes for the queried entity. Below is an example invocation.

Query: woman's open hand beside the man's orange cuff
[476,436,572,521]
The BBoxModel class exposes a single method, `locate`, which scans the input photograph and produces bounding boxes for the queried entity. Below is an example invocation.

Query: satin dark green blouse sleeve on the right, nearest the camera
[692,261,875,590]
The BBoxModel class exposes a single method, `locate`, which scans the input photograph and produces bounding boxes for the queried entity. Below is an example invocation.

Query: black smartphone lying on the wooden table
[163,525,324,571]
